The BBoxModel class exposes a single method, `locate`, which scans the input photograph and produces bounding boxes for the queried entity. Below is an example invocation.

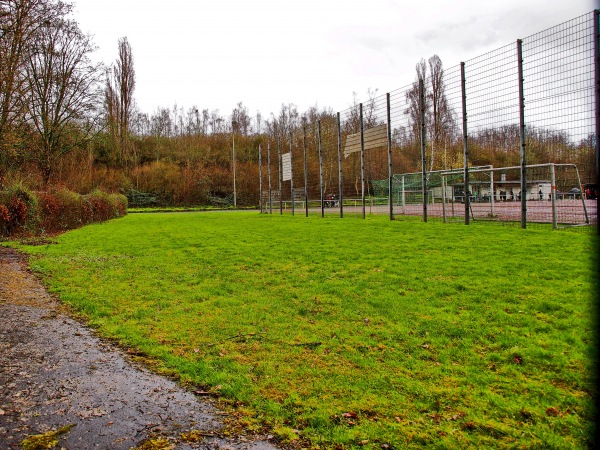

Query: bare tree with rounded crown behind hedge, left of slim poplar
[25,18,102,184]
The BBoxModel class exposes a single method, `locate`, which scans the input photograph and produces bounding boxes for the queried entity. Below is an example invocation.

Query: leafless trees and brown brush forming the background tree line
[0,0,595,205]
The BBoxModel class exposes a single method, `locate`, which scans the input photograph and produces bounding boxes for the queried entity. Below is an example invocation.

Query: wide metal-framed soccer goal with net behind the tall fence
[371,163,597,228]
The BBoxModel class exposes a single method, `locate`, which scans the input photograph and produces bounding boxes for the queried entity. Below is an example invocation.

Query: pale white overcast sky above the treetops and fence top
[74,0,598,118]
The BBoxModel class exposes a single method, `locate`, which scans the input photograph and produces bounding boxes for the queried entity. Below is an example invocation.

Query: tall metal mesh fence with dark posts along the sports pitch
[260,11,600,228]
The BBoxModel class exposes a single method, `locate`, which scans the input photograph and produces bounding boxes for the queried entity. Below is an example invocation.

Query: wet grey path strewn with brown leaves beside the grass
[0,247,275,450]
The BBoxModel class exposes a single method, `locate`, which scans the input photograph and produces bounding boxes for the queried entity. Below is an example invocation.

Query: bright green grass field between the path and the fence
[11,212,595,448]
